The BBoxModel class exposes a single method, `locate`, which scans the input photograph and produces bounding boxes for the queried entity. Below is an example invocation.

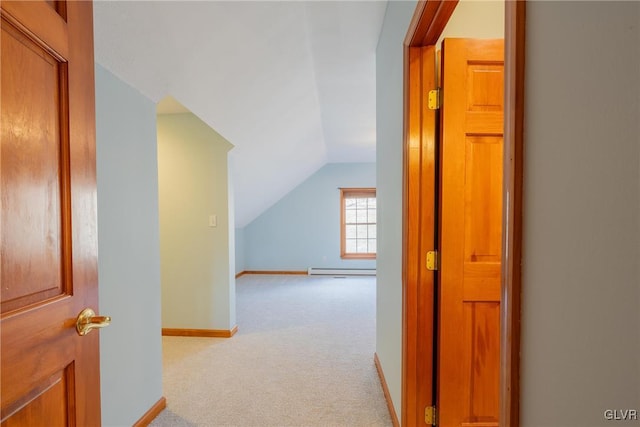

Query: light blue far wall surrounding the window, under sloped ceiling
[238,163,376,271]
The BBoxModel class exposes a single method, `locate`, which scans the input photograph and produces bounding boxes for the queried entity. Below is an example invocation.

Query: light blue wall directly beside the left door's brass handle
[96,64,162,426]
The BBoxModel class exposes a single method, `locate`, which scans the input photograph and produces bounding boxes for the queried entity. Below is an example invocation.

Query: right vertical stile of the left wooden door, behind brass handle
[66,1,100,425]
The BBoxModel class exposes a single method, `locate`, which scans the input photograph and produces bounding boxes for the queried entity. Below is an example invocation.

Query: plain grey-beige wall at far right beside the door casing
[521,2,640,427]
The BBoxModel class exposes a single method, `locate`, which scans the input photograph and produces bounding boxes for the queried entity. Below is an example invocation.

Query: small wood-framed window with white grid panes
[340,188,377,259]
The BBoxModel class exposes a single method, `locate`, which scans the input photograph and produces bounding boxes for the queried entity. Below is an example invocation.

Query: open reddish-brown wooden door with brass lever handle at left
[0,0,108,427]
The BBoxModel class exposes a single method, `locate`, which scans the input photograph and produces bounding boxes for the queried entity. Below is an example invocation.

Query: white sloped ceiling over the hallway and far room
[94,1,386,227]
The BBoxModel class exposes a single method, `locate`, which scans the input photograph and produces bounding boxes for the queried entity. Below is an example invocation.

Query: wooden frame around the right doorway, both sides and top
[401,0,526,427]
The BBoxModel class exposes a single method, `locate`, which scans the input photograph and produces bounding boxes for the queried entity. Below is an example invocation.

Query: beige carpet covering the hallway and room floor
[151,275,392,427]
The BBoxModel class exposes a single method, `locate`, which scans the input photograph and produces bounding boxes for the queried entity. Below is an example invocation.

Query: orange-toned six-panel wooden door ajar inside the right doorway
[437,39,504,427]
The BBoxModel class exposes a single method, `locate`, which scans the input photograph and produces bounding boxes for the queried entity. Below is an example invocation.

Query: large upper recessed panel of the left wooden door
[0,15,71,313]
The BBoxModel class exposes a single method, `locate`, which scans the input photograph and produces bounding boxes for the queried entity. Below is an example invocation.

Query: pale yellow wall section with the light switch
[157,113,235,330]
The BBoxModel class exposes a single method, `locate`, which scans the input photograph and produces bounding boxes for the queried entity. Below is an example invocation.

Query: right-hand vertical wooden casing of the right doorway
[500,0,526,427]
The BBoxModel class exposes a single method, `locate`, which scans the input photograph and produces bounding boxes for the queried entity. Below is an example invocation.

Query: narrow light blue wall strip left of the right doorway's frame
[376,1,416,416]
